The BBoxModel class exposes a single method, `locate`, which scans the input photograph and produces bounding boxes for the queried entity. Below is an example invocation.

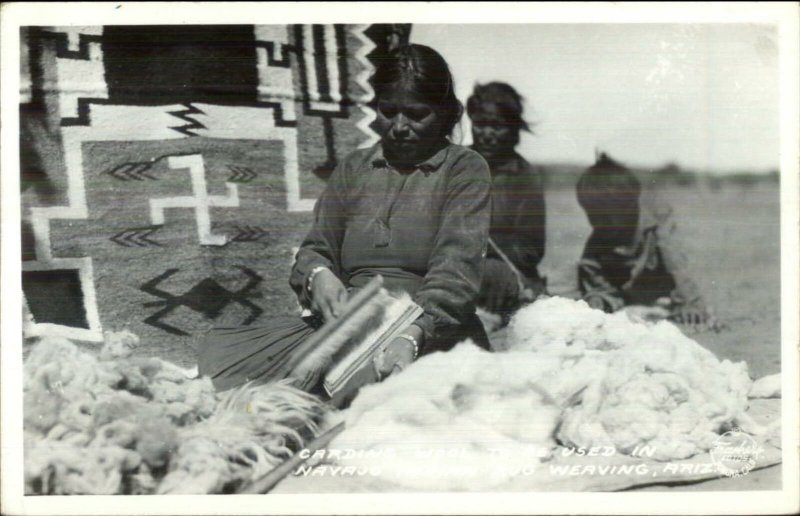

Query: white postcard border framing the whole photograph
[0,2,800,514]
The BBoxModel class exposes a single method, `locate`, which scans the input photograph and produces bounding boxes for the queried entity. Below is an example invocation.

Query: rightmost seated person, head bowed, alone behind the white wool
[576,154,716,328]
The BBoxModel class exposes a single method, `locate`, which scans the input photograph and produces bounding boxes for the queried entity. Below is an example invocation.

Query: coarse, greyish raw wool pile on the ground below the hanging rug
[23,333,323,494]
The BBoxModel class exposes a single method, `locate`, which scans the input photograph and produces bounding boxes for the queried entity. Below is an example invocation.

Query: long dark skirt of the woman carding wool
[198,314,490,393]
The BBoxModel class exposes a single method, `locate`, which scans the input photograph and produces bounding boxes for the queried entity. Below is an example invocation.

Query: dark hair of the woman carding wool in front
[372,44,464,136]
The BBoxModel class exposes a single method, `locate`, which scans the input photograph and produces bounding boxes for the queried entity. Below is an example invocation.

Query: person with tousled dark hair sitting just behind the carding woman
[467,82,545,320]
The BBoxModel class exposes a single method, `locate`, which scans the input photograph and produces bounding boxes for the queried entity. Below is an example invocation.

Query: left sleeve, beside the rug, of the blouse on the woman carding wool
[289,161,347,308]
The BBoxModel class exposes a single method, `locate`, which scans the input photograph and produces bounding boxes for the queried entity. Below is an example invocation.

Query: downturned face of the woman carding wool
[377,91,442,164]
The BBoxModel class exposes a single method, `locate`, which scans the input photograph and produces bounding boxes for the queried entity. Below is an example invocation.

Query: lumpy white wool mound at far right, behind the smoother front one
[509,298,758,460]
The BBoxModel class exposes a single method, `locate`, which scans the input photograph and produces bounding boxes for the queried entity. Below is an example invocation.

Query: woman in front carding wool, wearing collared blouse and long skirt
[199,45,491,390]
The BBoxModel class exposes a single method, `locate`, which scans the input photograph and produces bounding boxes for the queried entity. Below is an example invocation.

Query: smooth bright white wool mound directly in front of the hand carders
[331,341,560,491]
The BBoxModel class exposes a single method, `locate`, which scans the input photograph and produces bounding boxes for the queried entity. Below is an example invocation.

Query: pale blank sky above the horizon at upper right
[411,24,780,172]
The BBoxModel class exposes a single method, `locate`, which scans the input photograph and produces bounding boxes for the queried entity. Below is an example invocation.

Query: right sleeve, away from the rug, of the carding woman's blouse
[415,154,491,348]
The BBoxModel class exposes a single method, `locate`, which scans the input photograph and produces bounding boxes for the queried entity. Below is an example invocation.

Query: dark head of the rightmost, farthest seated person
[575,153,641,213]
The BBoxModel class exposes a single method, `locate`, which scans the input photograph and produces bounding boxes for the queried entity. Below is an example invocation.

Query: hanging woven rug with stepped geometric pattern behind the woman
[20,25,407,362]
